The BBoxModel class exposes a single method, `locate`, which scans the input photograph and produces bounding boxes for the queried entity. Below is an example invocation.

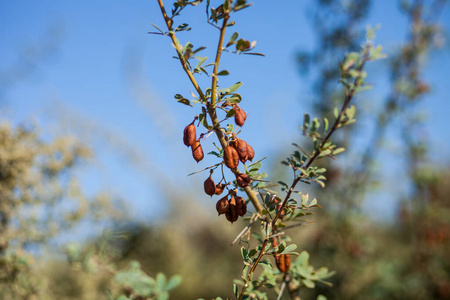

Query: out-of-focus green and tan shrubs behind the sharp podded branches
[0,0,450,300]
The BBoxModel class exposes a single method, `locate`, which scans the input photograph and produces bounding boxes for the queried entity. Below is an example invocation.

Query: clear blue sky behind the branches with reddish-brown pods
[0,0,450,223]
